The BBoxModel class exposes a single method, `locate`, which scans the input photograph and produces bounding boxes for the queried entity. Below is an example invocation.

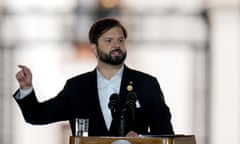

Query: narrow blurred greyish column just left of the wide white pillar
[192,42,209,144]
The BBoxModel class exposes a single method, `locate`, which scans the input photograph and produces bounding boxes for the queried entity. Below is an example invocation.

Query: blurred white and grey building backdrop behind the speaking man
[0,0,240,144]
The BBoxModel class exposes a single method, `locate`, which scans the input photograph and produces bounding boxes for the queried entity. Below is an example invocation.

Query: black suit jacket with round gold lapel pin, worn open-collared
[14,66,174,136]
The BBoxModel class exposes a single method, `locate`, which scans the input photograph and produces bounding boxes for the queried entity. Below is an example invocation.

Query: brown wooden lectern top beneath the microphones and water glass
[70,135,196,144]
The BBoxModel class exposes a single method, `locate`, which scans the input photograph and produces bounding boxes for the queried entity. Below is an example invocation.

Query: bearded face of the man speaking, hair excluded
[96,27,127,65]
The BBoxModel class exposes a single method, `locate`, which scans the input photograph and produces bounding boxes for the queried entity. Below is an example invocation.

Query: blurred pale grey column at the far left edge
[0,46,12,144]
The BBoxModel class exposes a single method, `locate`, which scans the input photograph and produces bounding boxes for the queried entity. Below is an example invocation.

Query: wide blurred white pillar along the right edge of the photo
[209,8,240,144]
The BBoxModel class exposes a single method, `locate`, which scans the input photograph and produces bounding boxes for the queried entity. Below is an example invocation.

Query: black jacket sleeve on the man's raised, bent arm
[13,82,70,124]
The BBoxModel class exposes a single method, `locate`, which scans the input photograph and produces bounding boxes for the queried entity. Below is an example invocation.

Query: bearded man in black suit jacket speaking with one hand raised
[14,18,174,137]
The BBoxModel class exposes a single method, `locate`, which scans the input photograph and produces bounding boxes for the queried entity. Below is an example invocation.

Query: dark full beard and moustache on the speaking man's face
[97,48,127,65]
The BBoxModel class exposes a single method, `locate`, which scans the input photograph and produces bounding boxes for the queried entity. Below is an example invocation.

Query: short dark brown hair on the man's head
[88,18,127,44]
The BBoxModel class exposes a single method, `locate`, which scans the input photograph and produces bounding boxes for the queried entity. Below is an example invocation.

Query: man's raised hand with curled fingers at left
[16,65,32,89]
